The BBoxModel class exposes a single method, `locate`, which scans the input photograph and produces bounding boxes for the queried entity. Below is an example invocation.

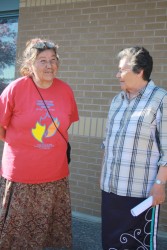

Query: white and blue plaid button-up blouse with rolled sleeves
[101,81,167,197]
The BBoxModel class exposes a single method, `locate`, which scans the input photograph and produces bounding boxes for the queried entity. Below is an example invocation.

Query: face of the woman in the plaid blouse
[116,57,143,94]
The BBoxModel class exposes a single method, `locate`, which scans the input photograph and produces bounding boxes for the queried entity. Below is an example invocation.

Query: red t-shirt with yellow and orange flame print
[0,77,78,183]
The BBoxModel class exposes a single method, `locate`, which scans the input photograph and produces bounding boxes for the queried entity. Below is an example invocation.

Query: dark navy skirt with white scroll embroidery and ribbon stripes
[102,191,159,250]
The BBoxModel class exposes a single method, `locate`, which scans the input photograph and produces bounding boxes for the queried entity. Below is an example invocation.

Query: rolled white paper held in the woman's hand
[130,196,153,216]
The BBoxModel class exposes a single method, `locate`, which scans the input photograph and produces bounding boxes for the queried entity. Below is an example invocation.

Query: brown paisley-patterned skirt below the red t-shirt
[0,177,72,250]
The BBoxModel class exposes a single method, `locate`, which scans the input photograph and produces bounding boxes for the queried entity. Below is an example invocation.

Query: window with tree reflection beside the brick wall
[0,14,18,84]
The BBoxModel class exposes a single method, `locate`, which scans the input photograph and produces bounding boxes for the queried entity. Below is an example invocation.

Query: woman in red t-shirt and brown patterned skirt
[0,38,78,250]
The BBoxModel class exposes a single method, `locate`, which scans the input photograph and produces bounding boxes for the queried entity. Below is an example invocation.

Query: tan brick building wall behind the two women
[10,0,167,231]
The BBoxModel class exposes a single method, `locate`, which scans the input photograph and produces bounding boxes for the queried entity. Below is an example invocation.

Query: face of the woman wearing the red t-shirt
[32,49,58,84]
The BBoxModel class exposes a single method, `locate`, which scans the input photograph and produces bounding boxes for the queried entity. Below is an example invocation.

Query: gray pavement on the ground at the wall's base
[73,213,167,250]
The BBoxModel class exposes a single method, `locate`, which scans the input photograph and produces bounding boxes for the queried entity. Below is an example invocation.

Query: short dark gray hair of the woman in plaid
[118,46,153,81]
